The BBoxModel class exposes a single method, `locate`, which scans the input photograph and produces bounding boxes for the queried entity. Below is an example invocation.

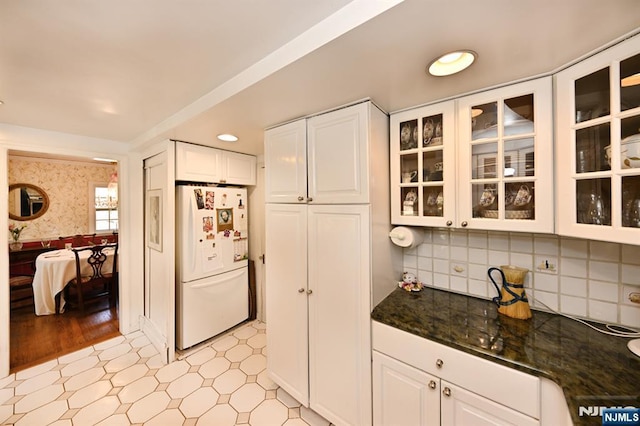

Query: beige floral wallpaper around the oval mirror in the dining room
[6,155,114,241]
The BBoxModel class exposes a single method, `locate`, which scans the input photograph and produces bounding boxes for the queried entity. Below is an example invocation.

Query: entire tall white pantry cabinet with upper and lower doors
[265,102,402,425]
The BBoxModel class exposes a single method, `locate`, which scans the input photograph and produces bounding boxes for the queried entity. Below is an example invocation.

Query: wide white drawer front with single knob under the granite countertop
[372,321,540,419]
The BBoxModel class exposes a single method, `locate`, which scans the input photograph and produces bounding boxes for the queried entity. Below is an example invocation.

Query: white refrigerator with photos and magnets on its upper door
[176,185,249,349]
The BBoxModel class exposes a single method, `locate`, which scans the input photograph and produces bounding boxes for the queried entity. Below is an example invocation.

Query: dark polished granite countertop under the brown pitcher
[371,288,640,425]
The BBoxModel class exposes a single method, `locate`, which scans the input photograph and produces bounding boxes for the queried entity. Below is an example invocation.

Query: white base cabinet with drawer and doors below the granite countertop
[372,321,542,426]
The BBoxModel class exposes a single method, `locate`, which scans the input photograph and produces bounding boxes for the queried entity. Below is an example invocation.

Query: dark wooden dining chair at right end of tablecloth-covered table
[56,243,118,314]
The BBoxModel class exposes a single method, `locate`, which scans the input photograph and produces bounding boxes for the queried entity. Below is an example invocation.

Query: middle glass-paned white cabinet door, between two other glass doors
[458,77,554,232]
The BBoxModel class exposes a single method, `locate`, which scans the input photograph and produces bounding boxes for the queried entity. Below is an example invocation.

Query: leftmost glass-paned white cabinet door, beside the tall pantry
[390,101,456,226]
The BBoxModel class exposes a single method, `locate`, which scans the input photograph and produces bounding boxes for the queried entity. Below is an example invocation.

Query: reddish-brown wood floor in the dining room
[10,299,120,373]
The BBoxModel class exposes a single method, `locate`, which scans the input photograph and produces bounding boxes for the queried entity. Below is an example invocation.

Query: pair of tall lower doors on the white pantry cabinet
[266,204,371,425]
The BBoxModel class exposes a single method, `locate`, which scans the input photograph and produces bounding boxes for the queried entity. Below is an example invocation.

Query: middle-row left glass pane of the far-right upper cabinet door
[576,123,611,173]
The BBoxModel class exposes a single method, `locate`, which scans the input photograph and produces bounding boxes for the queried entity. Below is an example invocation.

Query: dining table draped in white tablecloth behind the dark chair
[33,247,115,315]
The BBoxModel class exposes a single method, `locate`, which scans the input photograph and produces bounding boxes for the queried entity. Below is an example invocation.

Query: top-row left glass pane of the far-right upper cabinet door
[575,67,611,123]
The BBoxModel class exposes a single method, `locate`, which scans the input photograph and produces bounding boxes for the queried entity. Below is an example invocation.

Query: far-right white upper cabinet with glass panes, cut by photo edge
[556,36,640,244]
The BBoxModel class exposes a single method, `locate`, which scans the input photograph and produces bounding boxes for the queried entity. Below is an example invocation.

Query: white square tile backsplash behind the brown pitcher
[403,228,640,328]
